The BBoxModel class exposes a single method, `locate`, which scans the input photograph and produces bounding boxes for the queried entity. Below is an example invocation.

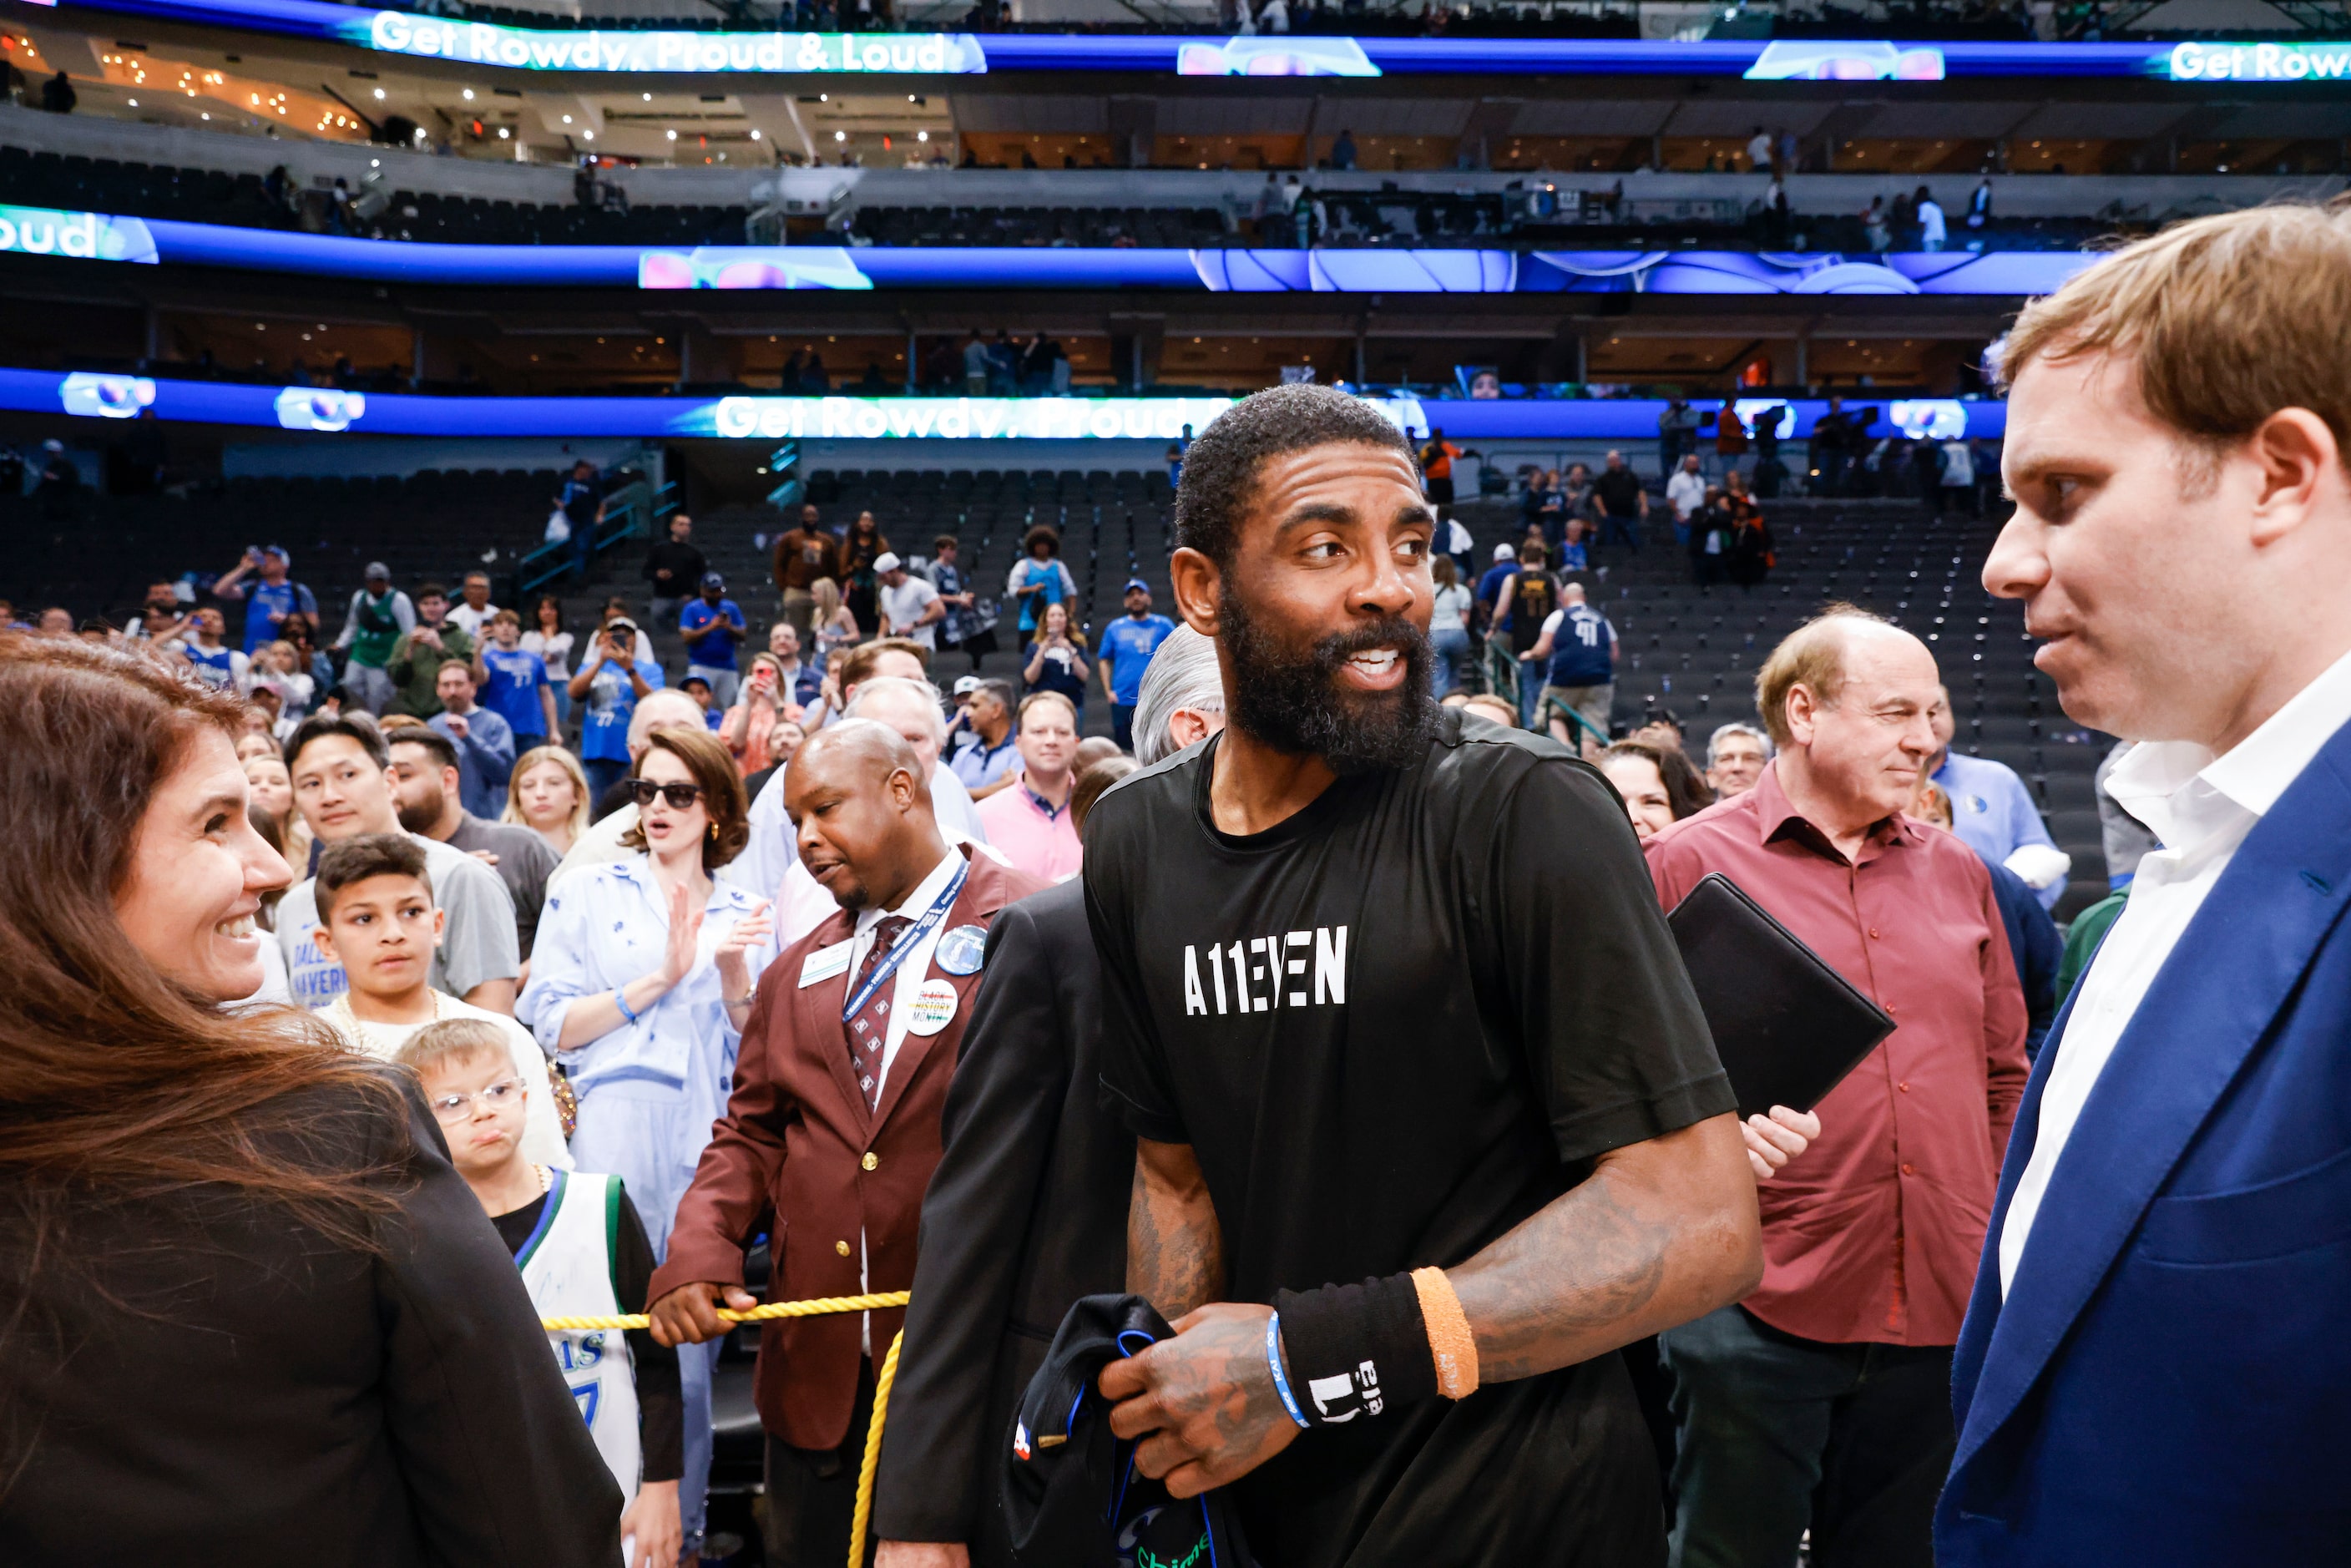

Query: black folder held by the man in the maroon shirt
[1665,873,1895,1116]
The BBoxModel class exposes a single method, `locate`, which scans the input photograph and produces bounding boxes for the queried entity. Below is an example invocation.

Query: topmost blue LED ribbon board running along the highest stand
[18,0,2275,83]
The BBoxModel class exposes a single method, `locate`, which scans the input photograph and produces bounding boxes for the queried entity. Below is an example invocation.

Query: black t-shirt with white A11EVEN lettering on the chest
[1086,710,1732,1568]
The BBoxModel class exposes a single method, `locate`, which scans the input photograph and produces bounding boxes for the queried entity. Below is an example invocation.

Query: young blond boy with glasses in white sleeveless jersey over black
[392,1018,684,1568]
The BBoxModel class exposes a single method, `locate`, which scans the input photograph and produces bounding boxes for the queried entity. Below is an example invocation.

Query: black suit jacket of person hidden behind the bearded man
[875,877,1135,1563]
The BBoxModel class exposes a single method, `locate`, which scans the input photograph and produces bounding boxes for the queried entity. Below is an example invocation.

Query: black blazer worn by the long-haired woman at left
[0,1067,620,1568]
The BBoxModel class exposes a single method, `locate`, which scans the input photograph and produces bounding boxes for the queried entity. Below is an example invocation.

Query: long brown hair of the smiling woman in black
[0,632,409,1363]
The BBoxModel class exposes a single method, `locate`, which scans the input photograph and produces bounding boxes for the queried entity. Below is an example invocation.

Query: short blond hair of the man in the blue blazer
[1999,202,2351,472]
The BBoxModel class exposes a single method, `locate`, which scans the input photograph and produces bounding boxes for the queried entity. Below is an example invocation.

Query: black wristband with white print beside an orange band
[1274,1274,1437,1427]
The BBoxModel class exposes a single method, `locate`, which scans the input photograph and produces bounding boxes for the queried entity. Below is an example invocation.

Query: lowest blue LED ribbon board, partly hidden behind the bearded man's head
[0,369,2008,442]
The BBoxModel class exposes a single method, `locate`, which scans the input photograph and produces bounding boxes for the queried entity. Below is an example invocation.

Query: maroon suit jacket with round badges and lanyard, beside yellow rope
[651,844,1044,1448]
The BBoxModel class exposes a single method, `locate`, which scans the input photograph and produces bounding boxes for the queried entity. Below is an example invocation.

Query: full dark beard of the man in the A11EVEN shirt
[1218,583,1437,773]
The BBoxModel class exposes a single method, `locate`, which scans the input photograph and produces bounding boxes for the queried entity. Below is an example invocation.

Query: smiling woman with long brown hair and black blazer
[0,635,620,1568]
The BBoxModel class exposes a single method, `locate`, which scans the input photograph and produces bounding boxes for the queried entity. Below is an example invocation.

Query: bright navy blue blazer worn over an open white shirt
[1935,726,2351,1568]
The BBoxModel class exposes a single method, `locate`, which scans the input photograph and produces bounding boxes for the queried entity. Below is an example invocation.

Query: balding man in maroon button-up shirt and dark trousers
[1646,606,2026,1568]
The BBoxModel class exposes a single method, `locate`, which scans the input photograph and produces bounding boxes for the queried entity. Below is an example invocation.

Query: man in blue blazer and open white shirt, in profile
[1935,207,2351,1568]
